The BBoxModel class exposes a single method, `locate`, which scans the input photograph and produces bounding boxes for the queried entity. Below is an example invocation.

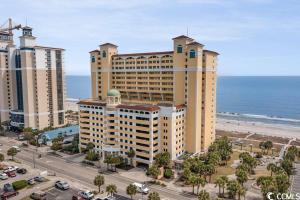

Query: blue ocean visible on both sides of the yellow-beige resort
[66,76,300,126]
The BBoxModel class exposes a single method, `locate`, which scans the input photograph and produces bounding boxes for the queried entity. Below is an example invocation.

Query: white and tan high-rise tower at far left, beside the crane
[0,26,65,129]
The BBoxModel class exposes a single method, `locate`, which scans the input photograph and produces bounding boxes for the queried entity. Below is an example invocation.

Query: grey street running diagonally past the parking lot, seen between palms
[0,138,192,200]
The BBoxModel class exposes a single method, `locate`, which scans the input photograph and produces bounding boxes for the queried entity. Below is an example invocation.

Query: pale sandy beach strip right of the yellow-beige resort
[216,118,300,139]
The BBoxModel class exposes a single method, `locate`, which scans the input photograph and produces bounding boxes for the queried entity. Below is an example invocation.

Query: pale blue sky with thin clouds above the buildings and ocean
[0,0,300,76]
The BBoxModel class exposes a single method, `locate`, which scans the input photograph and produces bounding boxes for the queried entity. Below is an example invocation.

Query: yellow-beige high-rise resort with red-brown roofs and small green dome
[79,36,218,165]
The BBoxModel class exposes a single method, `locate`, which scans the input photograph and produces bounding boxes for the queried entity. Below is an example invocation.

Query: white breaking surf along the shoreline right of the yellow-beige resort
[217,112,300,123]
